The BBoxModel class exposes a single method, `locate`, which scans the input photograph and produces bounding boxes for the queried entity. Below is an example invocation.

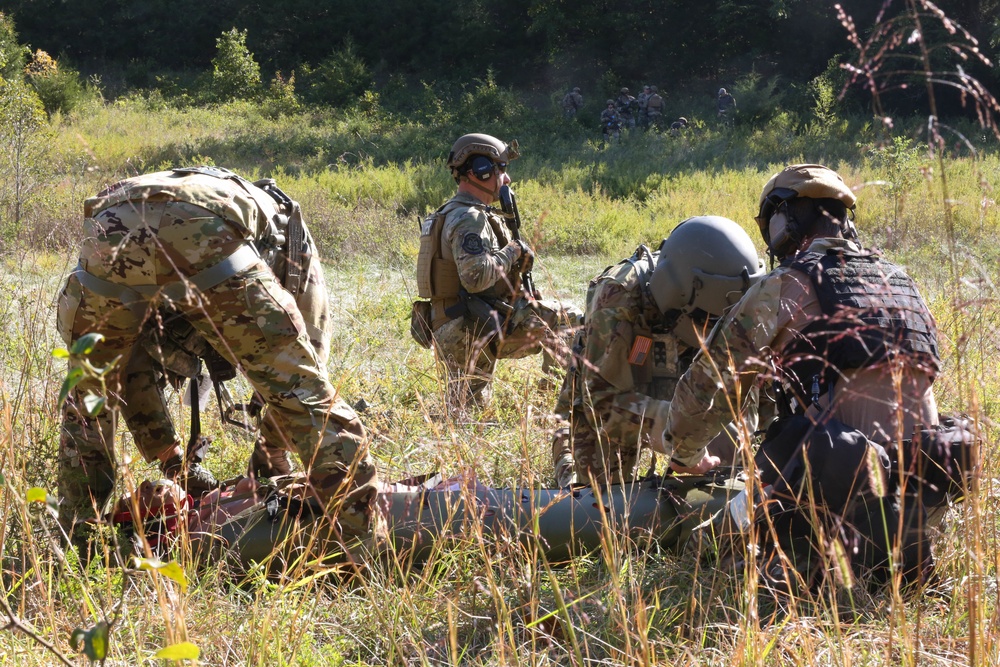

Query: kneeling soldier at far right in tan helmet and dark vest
[663,164,952,591]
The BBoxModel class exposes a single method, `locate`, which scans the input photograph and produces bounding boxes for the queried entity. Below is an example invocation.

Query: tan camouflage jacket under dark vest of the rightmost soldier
[665,238,933,464]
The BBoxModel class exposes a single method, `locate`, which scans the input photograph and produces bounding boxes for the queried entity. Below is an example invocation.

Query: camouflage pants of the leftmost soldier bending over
[59,202,377,552]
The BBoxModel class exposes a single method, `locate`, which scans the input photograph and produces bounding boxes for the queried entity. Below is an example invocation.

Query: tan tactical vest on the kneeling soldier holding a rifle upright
[417,201,510,330]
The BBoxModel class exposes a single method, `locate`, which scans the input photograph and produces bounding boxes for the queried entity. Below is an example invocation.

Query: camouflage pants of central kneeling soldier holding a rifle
[434,299,583,407]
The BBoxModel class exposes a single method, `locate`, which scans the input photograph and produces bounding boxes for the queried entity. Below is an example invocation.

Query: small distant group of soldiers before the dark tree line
[562,85,736,139]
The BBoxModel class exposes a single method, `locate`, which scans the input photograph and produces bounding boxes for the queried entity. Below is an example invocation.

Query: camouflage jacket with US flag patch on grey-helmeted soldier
[556,248,696,454]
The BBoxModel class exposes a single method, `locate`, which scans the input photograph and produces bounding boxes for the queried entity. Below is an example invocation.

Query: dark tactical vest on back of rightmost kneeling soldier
[782,250,941,403]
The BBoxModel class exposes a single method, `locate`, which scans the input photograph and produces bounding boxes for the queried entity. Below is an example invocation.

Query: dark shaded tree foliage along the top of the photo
[0,0,1000,112]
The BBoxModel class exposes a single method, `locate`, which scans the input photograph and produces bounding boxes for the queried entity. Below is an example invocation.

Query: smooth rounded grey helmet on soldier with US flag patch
[649,215,765,347]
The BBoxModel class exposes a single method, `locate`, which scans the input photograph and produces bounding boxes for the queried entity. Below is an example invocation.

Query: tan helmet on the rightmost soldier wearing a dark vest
[754,164,858,256]
